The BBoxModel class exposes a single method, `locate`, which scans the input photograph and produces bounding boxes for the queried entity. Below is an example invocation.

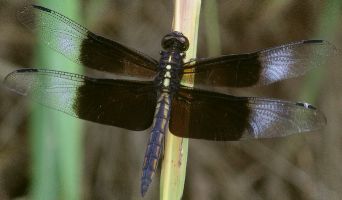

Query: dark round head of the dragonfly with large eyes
[161,31,189,52]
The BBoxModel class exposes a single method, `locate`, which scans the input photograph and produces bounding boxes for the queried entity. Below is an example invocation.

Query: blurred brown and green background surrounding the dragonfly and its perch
[0,0,342,200]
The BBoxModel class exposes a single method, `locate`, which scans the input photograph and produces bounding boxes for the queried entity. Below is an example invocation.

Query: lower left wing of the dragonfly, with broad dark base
[4,69,156,131]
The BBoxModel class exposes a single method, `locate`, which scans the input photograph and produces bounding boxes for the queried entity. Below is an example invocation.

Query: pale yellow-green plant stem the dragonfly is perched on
[160,0,201,200]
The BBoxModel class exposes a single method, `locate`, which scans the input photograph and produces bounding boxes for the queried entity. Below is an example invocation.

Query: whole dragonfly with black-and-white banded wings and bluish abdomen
[4,5,337,196]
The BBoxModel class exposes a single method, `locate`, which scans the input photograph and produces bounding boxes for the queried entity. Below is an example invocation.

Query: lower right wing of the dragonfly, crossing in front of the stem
[169,88,326,141]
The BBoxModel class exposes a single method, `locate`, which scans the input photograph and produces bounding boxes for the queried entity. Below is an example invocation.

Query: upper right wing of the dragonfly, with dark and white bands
[185,40,338,87]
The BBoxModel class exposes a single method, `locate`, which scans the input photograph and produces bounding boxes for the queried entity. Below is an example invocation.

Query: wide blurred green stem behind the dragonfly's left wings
[30,0,82,200]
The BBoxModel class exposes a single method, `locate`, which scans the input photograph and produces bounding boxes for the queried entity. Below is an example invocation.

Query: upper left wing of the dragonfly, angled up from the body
[18,5,157,78]
